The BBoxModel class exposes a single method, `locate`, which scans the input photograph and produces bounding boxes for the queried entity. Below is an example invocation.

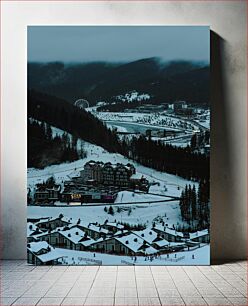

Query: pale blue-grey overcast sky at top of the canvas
[28,26,210,62]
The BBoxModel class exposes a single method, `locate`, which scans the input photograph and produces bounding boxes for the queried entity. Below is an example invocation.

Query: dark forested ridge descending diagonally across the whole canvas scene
[28,91,209,180]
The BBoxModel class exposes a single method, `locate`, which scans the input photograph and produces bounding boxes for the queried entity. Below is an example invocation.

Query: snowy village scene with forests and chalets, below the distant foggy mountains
[27,61,210,265]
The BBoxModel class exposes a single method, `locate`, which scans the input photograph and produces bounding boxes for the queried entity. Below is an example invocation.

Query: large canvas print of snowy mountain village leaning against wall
[27,26,210,265]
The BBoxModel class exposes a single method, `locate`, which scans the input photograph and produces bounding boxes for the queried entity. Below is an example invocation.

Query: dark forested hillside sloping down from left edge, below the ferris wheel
[28,91,120,152]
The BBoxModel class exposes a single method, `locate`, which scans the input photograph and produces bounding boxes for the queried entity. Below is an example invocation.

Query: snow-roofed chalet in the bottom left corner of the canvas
[27,241,63,265]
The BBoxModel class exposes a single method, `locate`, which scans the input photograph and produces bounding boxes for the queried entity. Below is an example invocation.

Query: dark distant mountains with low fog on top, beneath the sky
[28,57,209,105]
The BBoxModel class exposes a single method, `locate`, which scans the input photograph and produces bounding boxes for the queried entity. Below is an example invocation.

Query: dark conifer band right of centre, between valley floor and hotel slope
[122,136,209,181]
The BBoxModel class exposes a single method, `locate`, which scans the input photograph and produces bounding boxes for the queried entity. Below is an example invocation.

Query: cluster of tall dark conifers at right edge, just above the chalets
[179,180,210,229]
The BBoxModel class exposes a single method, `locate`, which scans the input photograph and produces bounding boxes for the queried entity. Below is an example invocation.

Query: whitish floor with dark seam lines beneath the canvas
[0,261,248,306]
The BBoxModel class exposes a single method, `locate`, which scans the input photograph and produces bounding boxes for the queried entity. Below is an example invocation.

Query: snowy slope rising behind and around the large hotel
[27,127,194,196]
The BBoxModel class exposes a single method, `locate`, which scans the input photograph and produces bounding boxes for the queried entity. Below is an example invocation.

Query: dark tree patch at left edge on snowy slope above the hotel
[28,120,86,168]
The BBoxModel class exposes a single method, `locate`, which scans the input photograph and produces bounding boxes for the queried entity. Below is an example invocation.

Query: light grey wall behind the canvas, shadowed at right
[1,1,247,260]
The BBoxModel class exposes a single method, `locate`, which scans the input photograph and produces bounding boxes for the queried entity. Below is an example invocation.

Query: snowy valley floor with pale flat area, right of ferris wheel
[88,108,210,148]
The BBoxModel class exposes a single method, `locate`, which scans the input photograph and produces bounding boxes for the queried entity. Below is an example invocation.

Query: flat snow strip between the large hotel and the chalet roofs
[27,201,184,227]
